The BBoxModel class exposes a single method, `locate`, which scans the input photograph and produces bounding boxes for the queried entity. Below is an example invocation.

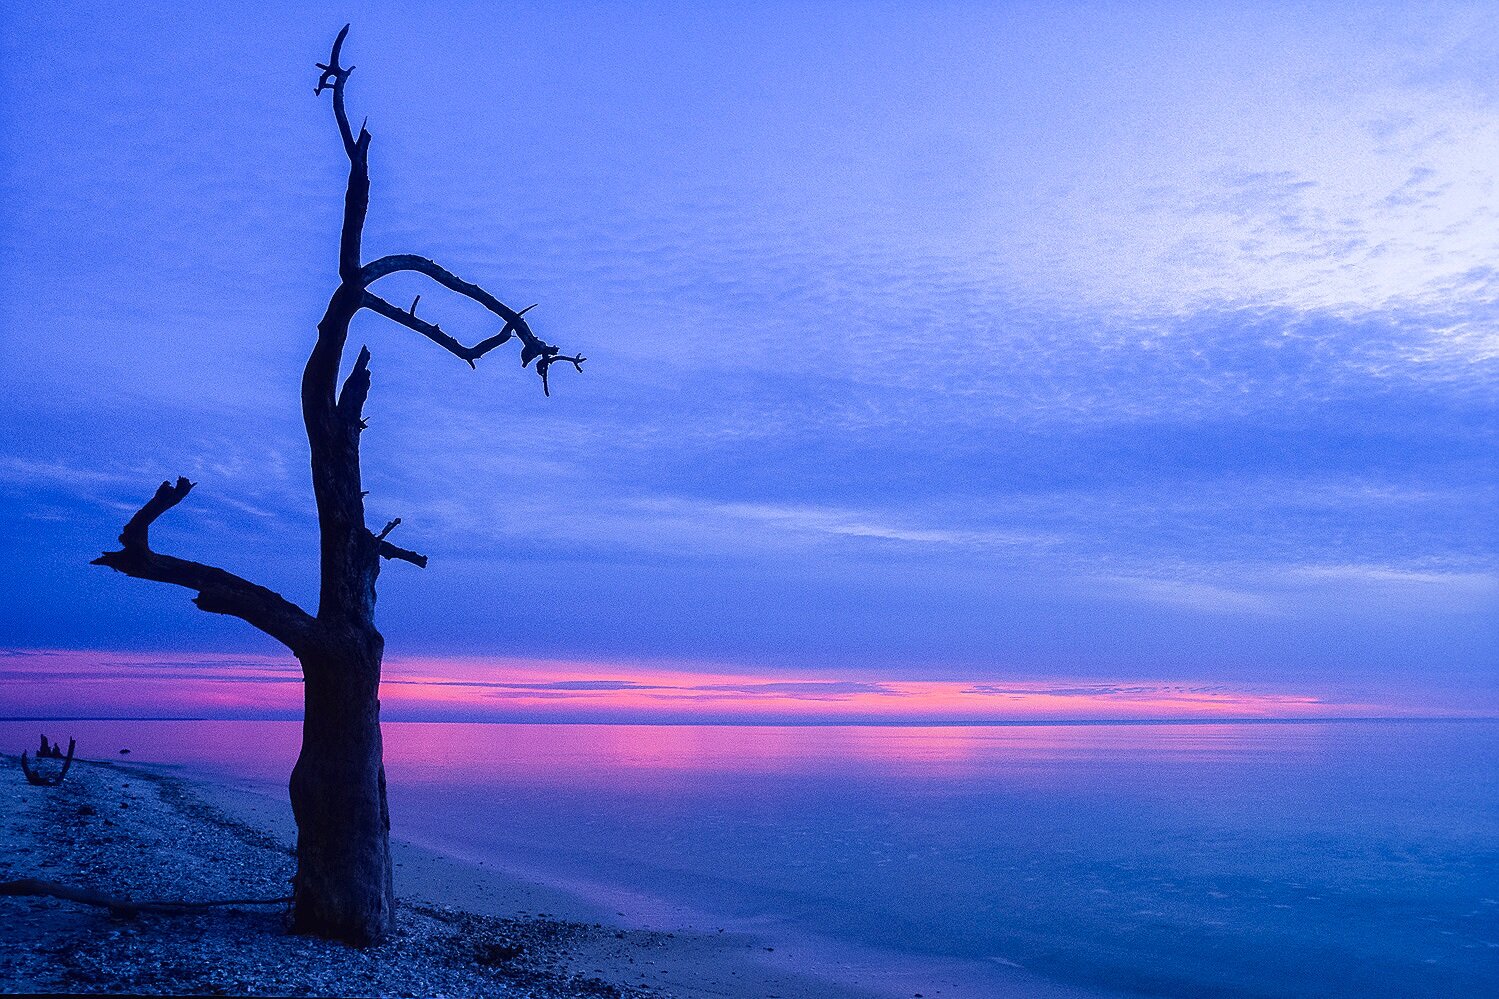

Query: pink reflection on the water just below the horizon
[0,720,1324,791]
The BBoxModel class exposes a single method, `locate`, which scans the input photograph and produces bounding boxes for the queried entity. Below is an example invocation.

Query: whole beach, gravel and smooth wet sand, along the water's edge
[0,758,1091,999]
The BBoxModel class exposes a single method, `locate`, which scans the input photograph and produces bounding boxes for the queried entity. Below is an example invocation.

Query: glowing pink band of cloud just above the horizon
[0,653,1415,723]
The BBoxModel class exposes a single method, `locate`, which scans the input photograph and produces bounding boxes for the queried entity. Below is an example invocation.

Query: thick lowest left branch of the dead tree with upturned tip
[93,477,316,651]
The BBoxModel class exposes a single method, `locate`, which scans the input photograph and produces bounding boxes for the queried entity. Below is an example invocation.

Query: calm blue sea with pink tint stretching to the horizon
[0,722,1499,998]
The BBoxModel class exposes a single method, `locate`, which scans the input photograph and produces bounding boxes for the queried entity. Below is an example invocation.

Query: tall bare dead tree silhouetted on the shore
[94,26,585,944]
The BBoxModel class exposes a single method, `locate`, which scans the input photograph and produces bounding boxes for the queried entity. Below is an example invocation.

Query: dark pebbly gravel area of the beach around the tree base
[0,756,663,999]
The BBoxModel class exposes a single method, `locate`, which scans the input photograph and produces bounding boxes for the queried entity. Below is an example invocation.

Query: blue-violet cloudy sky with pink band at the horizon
[0,0,1499,719]
